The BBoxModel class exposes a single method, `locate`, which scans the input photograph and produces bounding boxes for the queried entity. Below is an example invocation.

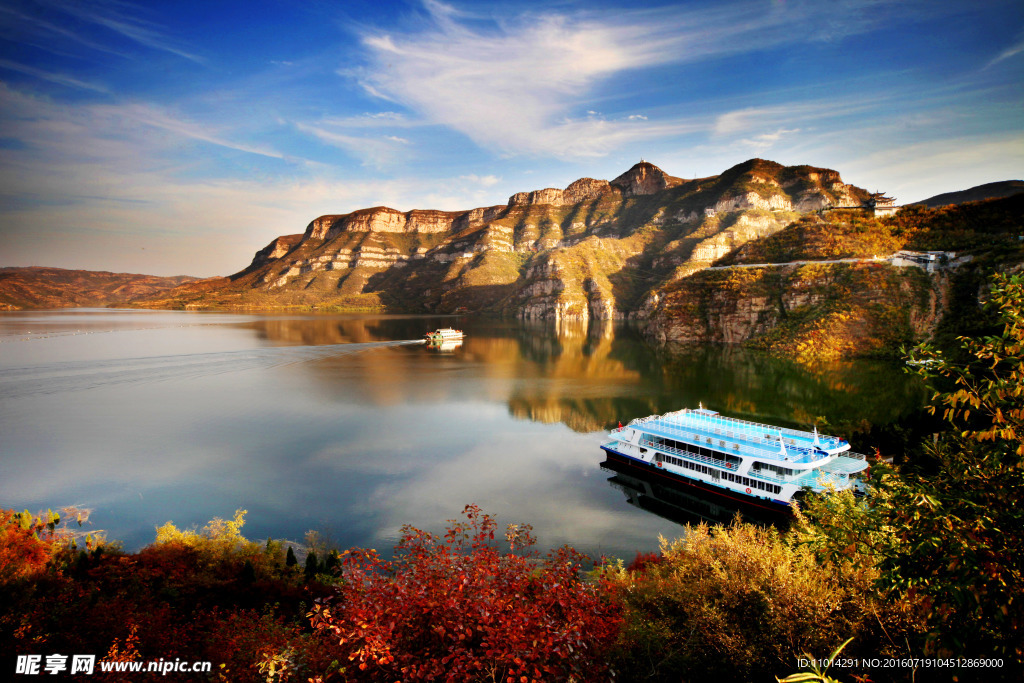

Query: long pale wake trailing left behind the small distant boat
[0,339,424,398]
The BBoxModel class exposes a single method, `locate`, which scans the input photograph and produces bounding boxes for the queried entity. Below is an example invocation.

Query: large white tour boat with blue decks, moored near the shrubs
[601,407,867,507]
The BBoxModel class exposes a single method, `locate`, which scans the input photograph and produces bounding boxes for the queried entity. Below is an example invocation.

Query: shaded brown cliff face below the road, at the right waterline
[647,263,948,360]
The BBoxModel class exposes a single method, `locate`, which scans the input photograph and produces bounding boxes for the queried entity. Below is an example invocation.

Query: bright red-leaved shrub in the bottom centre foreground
[311,505,621,683]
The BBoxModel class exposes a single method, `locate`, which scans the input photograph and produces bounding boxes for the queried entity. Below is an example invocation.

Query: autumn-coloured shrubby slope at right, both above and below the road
[647,195,1024,361]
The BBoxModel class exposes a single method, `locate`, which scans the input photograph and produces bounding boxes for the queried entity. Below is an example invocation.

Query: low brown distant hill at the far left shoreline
[0,266,196,310]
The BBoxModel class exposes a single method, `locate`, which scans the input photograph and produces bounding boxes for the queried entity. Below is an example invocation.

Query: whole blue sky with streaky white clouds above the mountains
[0,0,1024,276]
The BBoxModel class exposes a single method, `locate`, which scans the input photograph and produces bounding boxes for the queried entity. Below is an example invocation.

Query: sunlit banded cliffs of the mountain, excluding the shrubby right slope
[136,159,870,319]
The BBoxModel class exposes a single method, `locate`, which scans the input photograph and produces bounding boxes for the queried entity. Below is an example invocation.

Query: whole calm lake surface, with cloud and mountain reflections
[0,310,923,557]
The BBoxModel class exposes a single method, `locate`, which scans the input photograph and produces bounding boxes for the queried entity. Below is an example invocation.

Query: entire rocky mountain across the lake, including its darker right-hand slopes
[135,159,1024,361]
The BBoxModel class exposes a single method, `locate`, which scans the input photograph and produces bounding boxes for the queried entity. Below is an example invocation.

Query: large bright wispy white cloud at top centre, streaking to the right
[348,1,929,157]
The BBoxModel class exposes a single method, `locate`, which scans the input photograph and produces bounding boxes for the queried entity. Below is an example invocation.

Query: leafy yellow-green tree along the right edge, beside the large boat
[802,275,1024,667]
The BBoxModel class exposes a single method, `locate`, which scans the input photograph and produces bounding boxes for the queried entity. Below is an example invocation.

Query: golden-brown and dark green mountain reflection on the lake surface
[245,316,925,449]
